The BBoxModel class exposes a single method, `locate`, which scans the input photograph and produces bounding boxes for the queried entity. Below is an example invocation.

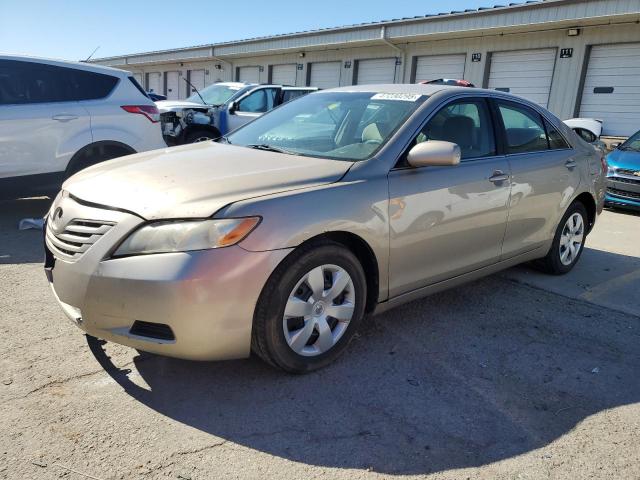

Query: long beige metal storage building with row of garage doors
[95,0,640,136]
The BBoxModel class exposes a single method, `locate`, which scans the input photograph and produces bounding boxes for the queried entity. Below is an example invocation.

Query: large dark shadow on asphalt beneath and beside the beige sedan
[88,262,640,474]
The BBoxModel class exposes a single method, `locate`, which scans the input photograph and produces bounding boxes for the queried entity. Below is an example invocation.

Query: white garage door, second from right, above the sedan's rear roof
[489,48,556,108]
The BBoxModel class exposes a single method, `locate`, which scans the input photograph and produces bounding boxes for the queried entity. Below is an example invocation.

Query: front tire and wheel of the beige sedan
[251,241,367,373]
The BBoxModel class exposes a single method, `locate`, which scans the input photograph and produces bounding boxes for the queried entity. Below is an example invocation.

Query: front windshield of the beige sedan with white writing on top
[226,92,427,162]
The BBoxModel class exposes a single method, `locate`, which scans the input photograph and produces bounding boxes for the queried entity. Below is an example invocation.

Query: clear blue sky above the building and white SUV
[0,0,495,60]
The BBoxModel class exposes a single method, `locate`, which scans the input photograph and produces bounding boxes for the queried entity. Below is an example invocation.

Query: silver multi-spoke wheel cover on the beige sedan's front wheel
[282,265,356,357]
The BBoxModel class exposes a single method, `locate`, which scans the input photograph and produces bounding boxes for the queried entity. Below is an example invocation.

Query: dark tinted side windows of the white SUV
[0,60,118,105]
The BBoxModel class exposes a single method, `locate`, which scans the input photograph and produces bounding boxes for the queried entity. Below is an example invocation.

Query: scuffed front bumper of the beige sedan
[46,195,290,360]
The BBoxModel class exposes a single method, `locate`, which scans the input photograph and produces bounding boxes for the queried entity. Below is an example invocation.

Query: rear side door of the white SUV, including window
[0,60,92,181]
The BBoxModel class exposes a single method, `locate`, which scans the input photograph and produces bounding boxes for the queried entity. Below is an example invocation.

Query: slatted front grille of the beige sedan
[46,219,115,260]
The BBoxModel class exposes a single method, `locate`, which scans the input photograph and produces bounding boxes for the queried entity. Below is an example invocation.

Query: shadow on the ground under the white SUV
[0,197,52,265]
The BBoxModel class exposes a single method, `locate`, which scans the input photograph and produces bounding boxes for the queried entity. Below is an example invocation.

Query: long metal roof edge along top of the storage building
[93,0,640,65]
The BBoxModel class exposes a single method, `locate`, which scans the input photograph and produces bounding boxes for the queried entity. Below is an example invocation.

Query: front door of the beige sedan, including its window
[389,97,510,296]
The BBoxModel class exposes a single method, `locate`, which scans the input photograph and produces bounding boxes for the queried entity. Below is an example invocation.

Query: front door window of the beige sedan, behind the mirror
[416,99,496,159]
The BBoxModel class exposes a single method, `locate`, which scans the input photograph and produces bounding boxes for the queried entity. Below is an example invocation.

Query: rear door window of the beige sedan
[498,102,549,153]
